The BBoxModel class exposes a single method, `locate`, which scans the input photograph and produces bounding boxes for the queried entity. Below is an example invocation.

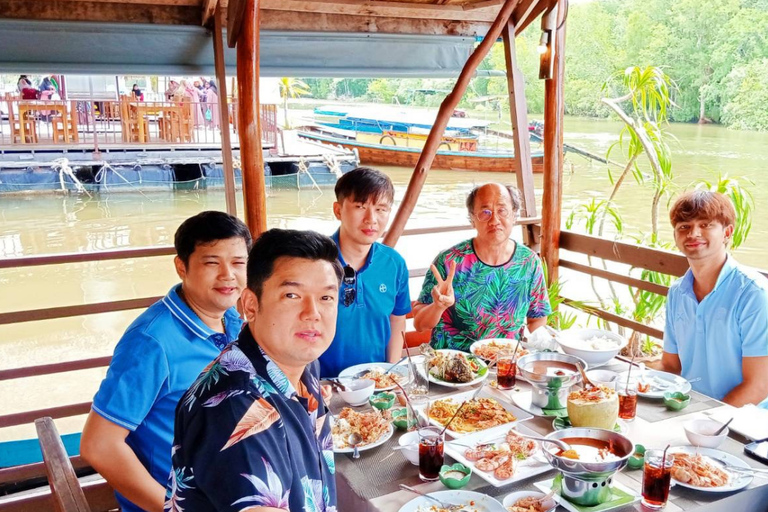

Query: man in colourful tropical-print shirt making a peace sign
[413,183,552,352]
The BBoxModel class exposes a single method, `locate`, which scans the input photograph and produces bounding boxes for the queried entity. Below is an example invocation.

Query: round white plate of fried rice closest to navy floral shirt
[331,407,394,453]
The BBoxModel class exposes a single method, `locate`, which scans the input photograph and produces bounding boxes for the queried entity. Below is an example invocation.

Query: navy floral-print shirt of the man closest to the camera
[165,328,337,512]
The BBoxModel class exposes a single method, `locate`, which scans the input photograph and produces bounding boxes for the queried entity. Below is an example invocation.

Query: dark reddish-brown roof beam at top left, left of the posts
[0,0,200,25]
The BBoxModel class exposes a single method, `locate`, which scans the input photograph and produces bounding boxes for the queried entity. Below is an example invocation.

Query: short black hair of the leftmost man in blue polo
[173,211,253,266]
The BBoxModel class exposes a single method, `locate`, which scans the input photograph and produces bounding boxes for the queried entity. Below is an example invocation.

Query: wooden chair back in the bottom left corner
[35,417,118,512]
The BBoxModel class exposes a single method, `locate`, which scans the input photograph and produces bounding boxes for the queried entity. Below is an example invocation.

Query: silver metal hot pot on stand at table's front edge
[542,428,634,506]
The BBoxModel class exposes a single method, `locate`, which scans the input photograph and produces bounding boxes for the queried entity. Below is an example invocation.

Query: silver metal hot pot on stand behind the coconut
[517,352,587,409]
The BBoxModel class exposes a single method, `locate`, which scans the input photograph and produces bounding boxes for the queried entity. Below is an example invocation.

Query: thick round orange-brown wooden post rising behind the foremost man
[237,0,267,238]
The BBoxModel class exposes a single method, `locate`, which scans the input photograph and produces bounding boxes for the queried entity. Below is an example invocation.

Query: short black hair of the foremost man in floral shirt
[248,228,343,299]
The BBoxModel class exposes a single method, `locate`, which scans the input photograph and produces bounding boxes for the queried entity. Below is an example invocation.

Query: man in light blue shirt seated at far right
[661,190,768,407]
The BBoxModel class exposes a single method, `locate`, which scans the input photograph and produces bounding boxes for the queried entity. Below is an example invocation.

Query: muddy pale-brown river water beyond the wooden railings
[0,119,768,440]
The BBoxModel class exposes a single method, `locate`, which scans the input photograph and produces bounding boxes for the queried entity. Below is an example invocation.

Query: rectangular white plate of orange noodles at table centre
[429,390,533,437]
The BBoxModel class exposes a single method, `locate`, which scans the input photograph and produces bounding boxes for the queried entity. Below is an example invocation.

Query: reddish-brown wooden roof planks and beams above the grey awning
[0,0,555,38]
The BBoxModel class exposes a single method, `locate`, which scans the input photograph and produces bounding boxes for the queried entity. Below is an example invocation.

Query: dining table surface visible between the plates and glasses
[330,358,768,512]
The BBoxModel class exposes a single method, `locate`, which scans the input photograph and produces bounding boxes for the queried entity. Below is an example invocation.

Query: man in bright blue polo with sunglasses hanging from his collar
[320,167,411,377]
